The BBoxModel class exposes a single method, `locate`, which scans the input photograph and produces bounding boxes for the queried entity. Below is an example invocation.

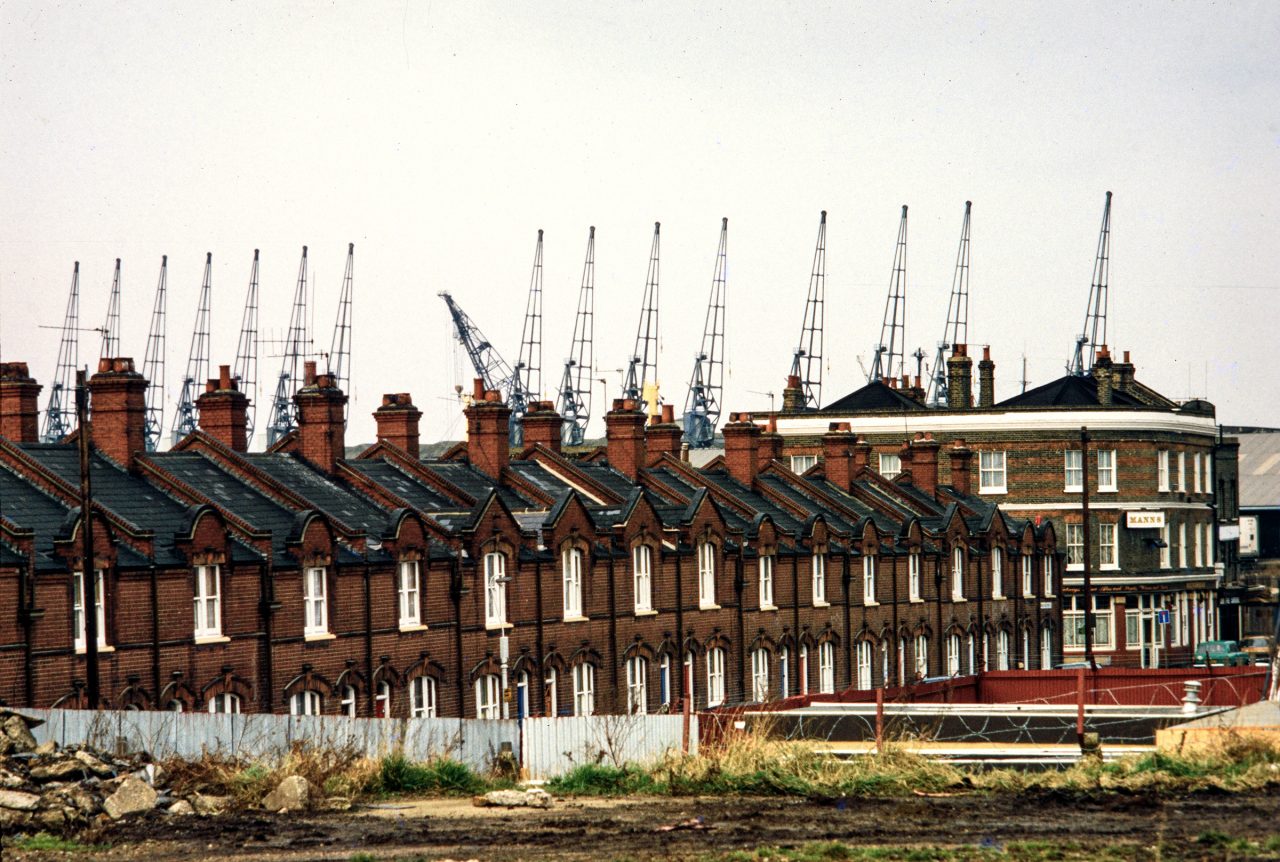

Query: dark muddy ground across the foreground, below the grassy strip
[3,794,1280,862]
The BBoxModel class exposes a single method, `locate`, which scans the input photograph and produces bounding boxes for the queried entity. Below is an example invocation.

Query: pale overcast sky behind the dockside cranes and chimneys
[0,1,1280,442]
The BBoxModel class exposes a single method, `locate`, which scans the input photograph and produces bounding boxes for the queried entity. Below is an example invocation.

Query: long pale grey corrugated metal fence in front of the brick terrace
[12,710,698,779]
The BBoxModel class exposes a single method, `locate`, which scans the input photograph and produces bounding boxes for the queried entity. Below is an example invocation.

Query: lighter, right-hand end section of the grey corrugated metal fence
[522,715,698,779]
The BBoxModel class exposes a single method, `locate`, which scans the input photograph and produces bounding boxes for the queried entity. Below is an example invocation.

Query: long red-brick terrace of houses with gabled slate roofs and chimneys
[0,357,1064,717]
